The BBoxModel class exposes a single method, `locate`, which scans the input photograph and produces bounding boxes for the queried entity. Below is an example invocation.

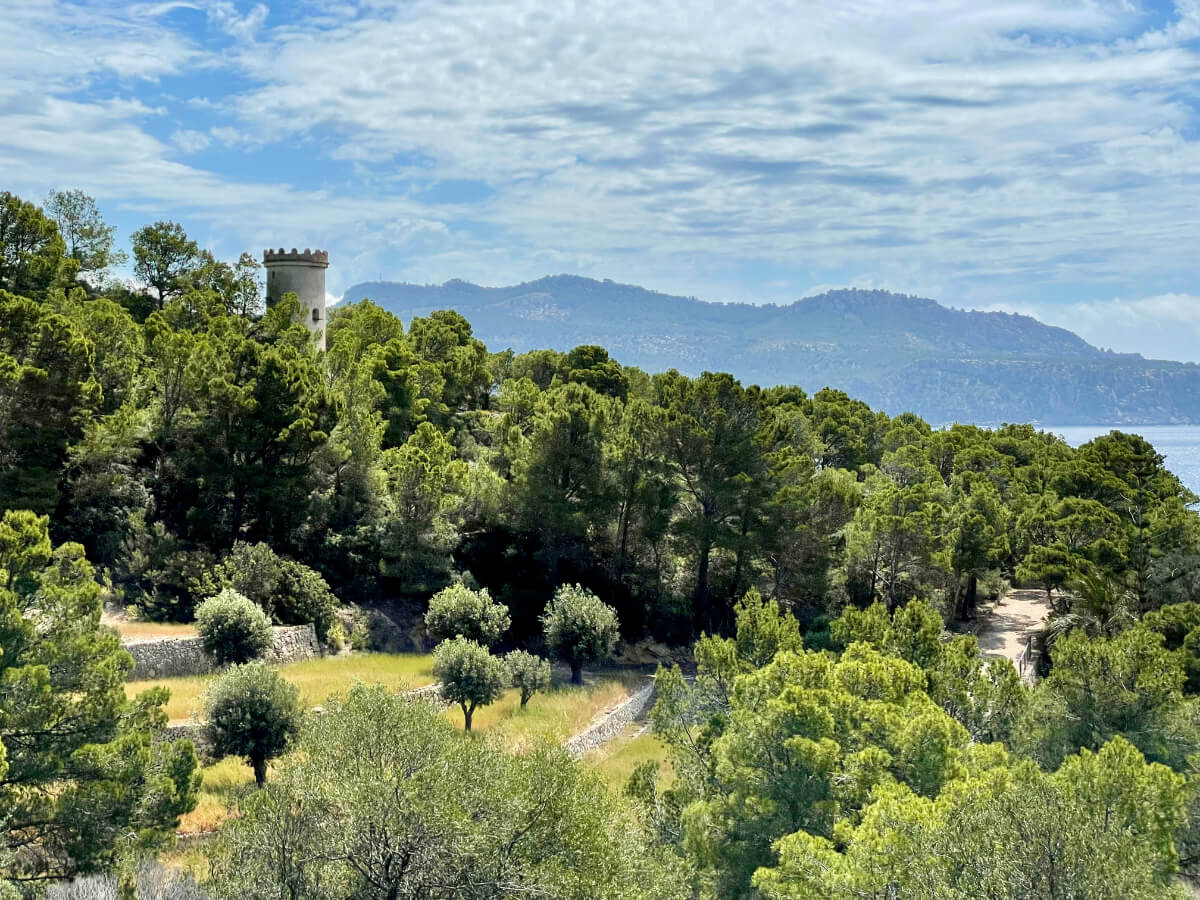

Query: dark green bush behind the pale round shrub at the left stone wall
[196,541,338,642]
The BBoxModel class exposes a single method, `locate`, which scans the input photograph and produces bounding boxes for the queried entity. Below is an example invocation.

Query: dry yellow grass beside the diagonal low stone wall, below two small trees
[445,672,646,751]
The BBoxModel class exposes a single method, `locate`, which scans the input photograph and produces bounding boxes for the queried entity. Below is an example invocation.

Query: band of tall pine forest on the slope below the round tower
[0,188,1200,641]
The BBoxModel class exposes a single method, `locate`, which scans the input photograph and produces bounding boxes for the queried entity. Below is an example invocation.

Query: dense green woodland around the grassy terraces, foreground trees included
[7,192,1200,900]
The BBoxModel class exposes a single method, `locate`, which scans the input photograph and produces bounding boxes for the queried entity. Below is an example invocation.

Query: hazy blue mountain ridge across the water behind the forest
[346,275,1200,425]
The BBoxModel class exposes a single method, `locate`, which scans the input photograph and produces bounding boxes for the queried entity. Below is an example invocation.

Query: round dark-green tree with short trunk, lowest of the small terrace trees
[204,662,301,787]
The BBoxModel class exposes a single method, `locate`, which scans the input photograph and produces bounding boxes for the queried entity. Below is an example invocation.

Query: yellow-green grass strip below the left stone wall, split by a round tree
[125,653,433,722]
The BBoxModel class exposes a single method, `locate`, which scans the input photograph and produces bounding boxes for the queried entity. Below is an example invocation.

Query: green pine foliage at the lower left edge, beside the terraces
[0,512,196,884]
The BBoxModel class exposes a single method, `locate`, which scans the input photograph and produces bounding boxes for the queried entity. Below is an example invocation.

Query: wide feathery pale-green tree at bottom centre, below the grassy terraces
[210,685,684,900]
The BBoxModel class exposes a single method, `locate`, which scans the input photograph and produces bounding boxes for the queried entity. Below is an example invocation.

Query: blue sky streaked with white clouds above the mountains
[0,0,1200,360]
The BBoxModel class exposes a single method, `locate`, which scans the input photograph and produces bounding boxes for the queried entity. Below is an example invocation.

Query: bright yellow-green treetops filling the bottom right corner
[754,738,1188,900]
